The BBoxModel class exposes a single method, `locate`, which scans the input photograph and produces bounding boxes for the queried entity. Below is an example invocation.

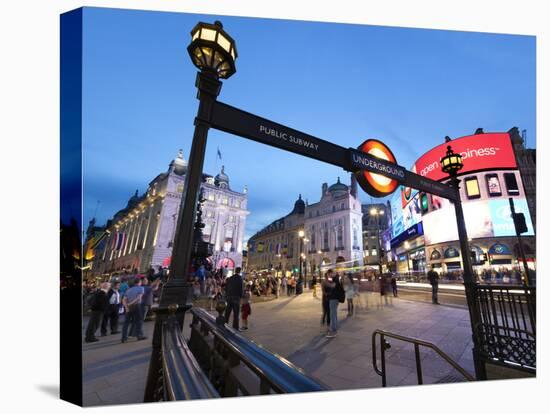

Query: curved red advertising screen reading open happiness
[412,133,517,180]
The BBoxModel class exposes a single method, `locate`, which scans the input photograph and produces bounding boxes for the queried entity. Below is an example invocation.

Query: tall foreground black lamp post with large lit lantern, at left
[160,21,237,307]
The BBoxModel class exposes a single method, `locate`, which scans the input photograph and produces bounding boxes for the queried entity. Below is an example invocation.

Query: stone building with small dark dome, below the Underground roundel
[247,175,363,275]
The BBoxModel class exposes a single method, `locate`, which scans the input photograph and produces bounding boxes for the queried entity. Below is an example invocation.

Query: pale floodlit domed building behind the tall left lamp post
[91,150,249,275]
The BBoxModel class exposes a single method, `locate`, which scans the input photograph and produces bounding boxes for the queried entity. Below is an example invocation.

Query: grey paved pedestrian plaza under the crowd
[83,291,474,405]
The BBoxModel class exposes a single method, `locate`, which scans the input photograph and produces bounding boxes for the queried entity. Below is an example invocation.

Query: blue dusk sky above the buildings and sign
[82,8,536,243]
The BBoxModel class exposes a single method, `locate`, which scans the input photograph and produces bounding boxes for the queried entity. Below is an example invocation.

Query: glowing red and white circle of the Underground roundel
[356,139,399,197]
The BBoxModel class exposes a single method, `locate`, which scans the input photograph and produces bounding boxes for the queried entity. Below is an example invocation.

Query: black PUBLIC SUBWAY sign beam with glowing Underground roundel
[211,101,457,200]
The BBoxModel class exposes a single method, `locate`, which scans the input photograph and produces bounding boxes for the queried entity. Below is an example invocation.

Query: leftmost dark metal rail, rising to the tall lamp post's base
[162,318,220,401]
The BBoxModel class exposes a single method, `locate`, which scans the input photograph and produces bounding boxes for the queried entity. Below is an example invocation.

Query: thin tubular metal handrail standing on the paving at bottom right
[372,329,475,387]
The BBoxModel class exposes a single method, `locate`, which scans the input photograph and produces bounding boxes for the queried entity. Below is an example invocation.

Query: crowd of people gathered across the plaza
[84,265,404,343]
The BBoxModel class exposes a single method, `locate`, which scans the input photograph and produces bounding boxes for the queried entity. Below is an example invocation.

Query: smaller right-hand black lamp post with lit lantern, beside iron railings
[441,145,487,379]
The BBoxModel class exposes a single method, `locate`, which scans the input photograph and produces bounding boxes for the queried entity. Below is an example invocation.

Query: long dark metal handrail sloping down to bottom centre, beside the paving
[191,308,326,393]
